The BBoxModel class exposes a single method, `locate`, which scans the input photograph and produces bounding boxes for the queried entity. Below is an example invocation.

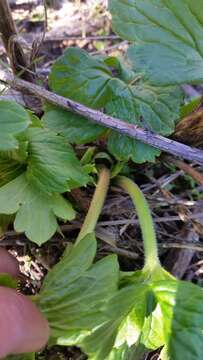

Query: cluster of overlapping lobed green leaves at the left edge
[0,100,88,245]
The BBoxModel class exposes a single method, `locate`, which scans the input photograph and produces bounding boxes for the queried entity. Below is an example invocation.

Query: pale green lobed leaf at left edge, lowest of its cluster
[0,173,75,245]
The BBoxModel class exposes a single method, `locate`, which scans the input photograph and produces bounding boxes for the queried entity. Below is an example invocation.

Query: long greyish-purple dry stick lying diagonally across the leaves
[0,71,203,165]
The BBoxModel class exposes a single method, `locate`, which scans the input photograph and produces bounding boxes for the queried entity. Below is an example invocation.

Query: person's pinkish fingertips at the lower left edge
[0,249,49,359]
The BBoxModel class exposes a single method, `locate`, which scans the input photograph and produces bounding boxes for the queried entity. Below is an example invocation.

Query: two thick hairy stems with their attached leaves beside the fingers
[27,169,203,360]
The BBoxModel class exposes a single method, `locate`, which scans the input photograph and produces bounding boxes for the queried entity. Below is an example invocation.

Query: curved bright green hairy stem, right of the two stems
[117,176,160,272]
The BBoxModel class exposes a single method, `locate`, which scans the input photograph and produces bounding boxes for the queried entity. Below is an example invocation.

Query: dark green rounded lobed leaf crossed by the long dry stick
[43,48,182,163]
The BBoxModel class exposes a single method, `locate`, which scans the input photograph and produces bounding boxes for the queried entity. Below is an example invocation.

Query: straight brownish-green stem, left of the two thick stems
[76,168,110,244]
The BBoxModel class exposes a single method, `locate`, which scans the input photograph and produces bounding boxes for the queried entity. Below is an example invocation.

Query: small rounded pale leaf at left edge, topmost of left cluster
[0,100,30,151]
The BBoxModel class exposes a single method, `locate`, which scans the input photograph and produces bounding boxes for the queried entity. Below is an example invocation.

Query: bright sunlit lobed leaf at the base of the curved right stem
[72,270,203,360]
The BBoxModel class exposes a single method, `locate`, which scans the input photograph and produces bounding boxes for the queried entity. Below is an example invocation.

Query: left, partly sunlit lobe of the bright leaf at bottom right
[81,285,149,360]
